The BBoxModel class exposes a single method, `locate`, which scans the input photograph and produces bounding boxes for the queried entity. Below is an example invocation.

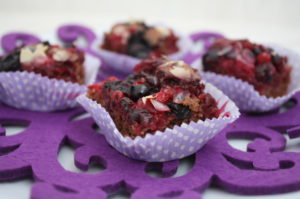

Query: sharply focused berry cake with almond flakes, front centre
[88,57,220,138]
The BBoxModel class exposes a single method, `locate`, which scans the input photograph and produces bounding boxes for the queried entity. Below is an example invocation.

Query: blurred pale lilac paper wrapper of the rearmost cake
[93,29,193,74]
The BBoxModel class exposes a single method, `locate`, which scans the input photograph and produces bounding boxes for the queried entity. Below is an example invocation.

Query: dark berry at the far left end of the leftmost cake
[0,50,21,72]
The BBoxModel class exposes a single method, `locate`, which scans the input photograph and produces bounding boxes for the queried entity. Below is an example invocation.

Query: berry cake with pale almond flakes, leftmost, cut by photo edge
[0,42,84,84]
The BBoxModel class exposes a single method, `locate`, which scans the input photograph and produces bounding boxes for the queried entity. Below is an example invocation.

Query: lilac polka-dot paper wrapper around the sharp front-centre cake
[77,83,240,162]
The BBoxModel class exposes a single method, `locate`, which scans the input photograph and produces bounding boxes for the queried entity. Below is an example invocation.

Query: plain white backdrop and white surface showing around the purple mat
[0,0,300,199]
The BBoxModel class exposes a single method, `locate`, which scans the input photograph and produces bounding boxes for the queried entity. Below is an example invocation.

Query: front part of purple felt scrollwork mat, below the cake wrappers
[0,24,300,199]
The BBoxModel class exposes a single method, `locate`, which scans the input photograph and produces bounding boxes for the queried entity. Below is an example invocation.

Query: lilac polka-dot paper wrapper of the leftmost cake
[0,55,100,111]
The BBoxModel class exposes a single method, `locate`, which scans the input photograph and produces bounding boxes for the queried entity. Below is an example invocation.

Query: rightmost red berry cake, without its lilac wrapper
[202,39,291,97]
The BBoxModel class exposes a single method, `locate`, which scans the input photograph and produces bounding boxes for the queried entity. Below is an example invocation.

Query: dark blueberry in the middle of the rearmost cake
[127,32,152,59]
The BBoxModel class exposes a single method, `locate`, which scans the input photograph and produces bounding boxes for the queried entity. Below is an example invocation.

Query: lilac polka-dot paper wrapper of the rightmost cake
[201,44,300,112]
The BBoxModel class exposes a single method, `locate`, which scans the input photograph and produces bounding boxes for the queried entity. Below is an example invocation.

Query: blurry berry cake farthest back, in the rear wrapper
[101,21,179,59]
